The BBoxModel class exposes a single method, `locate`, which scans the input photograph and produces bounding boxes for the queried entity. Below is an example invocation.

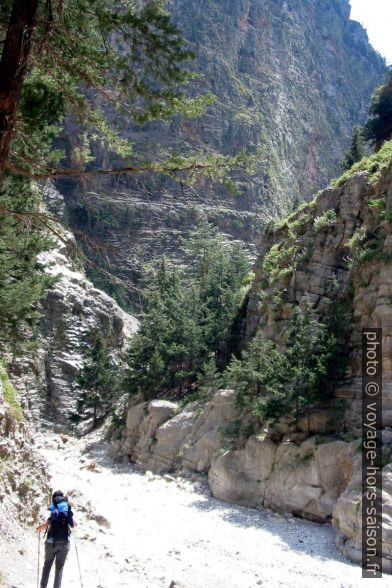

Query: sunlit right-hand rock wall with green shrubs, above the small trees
[245,166,392,428]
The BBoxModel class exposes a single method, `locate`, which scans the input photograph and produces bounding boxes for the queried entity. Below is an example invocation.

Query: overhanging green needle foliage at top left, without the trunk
[0,0,250,190]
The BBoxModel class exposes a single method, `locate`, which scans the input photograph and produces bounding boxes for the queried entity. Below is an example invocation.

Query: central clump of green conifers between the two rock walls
[127,224,249,399]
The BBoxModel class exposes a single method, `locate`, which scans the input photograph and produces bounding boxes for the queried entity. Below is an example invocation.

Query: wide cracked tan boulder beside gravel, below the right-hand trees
[209,437,354,522]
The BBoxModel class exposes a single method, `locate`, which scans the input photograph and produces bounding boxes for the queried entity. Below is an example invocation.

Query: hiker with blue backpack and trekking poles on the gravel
[37,490,76,588]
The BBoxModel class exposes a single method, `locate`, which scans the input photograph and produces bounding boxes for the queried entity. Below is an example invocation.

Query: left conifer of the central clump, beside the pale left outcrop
[127,260,202,398]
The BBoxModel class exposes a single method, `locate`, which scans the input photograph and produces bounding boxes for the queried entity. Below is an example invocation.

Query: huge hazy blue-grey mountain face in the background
[62,0,385,304]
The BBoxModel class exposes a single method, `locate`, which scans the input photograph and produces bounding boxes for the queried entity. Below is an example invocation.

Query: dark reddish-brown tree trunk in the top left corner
[0,0,38,187]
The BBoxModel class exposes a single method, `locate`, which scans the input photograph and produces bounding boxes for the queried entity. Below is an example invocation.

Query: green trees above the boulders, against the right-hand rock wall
[224,288,348,420]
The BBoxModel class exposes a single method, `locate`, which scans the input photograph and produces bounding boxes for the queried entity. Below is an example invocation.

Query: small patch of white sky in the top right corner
[350,0,392,64]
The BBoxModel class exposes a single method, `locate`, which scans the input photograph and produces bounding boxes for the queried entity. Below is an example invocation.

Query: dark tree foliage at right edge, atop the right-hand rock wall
[364,72,392,150]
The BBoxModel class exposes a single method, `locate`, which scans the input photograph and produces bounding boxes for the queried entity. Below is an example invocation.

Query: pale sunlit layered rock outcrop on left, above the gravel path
[10,233,138,430]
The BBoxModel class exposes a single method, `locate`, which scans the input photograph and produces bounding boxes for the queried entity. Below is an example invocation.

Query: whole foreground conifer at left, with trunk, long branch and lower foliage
[0,0,248,336]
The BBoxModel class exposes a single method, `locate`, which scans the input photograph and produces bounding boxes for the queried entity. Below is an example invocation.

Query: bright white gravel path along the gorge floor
[0,435,392,588]
